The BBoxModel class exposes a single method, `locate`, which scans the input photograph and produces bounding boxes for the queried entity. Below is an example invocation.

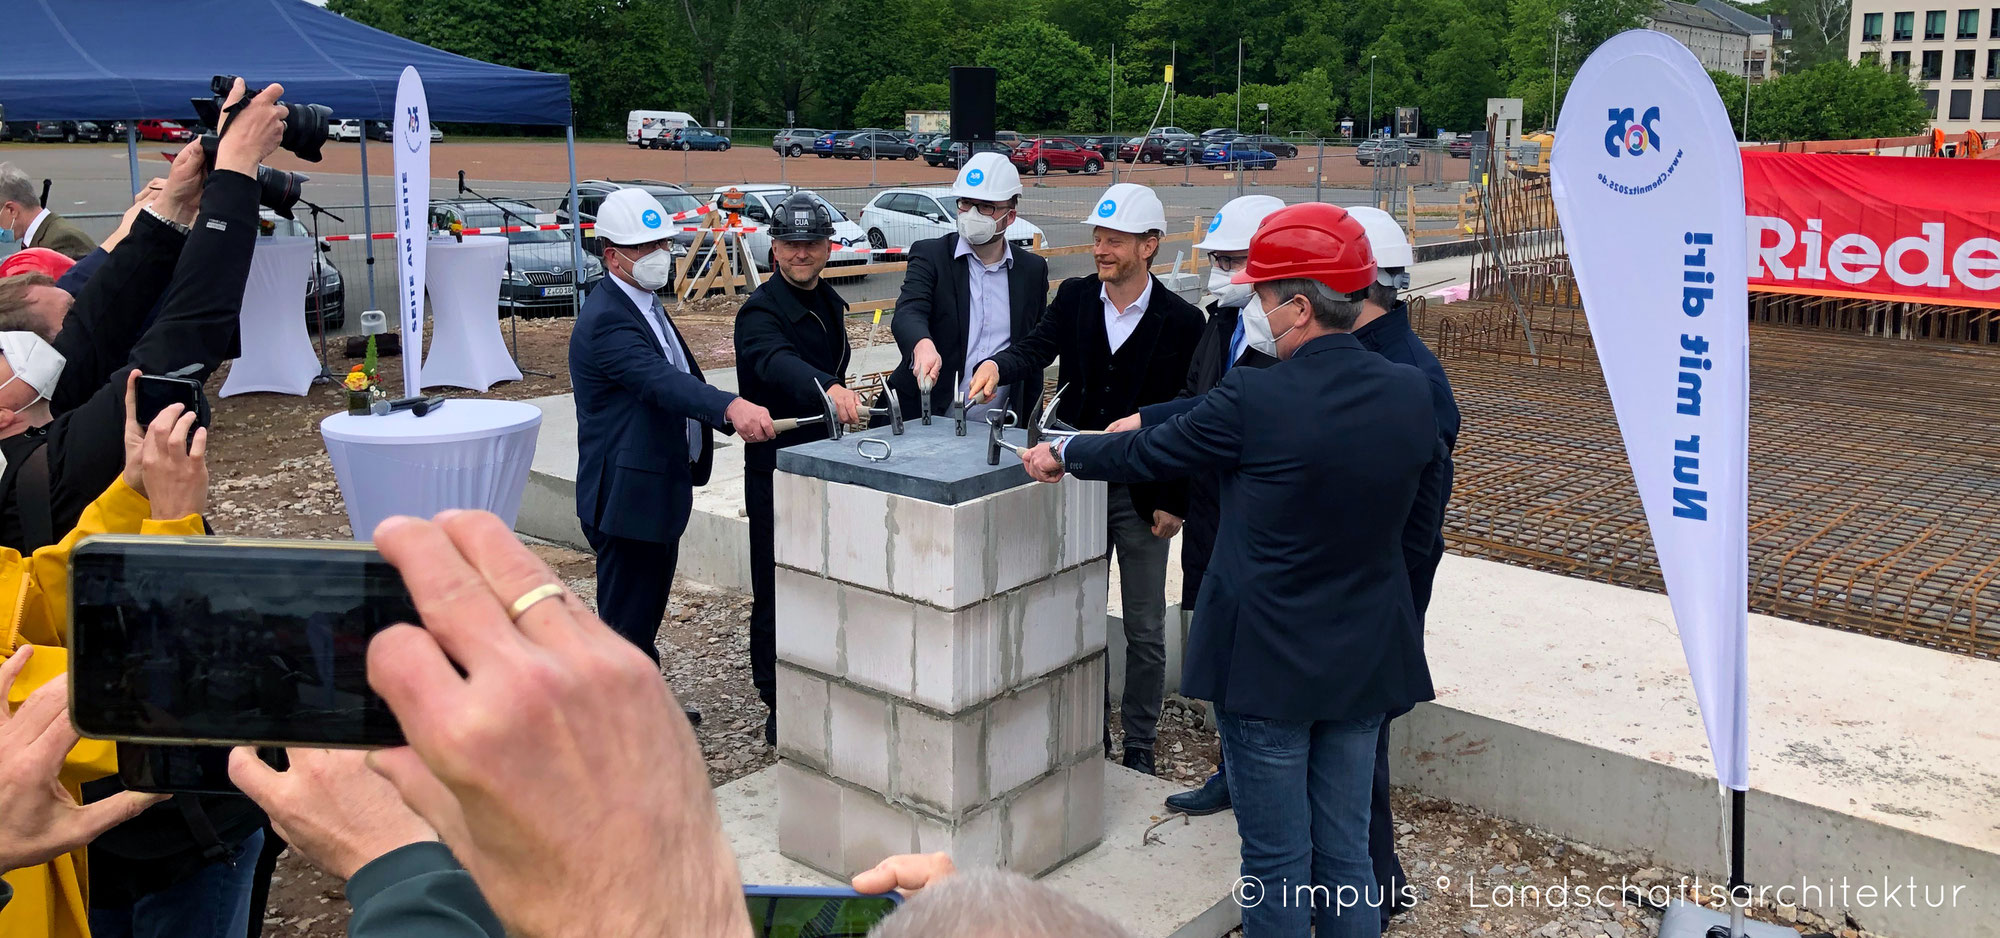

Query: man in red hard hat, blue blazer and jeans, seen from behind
[1022,202,1438,938]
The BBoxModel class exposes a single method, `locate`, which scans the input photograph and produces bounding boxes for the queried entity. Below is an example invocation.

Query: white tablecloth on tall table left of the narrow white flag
[220,238,320,398]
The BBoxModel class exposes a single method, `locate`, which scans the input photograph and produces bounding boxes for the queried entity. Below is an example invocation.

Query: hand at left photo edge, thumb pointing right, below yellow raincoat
[0,646,166,872]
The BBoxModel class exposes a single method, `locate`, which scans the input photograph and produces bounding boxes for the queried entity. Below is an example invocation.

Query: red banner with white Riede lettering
[1742,152,2000,308]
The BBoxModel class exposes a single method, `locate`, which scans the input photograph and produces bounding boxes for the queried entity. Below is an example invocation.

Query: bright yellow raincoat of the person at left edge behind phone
[0,476,206,938]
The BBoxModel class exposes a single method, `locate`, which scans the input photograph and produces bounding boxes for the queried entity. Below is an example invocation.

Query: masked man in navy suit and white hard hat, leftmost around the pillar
[570,188,772,660]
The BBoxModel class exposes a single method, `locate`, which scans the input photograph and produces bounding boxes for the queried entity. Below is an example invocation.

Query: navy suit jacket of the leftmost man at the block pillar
[570,274,736,544]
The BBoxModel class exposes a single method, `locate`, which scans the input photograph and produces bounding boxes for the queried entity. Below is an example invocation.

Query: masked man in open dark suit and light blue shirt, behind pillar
[888,152,1048,418]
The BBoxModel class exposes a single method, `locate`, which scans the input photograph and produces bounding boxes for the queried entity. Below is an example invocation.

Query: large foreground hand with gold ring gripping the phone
[368,512,750,938]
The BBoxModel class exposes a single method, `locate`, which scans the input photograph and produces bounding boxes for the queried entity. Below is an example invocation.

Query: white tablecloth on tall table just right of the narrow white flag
[424,234,520,390]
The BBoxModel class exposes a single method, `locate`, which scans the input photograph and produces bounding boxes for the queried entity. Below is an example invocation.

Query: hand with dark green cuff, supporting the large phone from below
[230,746,438,880]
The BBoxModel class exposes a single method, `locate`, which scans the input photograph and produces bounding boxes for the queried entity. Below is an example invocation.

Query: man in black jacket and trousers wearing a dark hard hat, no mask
[736,192,860,746]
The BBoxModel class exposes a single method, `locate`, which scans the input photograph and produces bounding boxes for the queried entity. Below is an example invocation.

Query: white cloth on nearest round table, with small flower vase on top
[320,398,542,540]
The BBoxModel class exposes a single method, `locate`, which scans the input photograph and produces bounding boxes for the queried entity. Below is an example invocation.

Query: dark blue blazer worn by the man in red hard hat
[1064,334,1438,720]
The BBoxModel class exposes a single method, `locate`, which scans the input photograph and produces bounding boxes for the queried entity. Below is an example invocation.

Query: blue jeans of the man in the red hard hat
[1216,710,1382,938]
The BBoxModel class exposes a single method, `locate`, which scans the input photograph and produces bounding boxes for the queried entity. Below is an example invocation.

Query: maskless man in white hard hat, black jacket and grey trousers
[970,182,1202,774]
